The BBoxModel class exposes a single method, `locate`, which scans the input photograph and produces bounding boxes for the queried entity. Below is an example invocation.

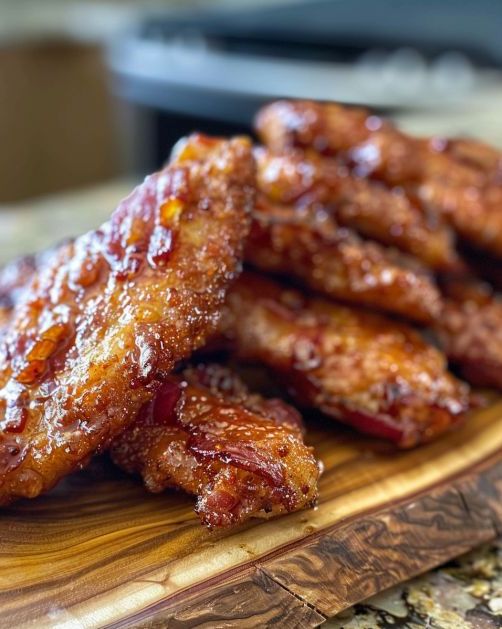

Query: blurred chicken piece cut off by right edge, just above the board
[435,278,502,390]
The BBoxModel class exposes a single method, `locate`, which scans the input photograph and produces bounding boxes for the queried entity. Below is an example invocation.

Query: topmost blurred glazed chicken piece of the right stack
[256,101,502,256]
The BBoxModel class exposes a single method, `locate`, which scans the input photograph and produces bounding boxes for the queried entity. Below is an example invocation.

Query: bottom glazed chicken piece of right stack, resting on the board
[220,273,470,447]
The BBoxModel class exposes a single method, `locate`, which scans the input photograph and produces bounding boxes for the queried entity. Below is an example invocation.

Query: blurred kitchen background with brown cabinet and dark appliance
[0,0,502,255]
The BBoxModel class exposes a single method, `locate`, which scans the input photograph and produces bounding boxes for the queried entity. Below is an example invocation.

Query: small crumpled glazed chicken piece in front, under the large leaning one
[111,365,319,528]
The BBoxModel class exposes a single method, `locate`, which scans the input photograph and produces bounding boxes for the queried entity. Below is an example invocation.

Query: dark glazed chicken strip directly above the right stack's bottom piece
[245,197,442,323]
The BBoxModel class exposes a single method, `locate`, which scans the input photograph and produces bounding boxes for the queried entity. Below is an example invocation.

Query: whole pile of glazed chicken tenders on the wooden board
[0,101,502,528]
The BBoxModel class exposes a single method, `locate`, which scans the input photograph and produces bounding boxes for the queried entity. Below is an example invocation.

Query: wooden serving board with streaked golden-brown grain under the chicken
[0,399,502,628]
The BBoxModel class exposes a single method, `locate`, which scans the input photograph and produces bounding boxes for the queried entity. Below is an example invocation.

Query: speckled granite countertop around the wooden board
[0,180,502,629]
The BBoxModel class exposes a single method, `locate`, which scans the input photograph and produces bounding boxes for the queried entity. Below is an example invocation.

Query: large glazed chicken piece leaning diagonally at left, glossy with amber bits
[0,138,254,504]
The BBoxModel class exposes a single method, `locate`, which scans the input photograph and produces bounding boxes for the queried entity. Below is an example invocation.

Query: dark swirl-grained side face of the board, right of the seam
[262,454,502,616]
